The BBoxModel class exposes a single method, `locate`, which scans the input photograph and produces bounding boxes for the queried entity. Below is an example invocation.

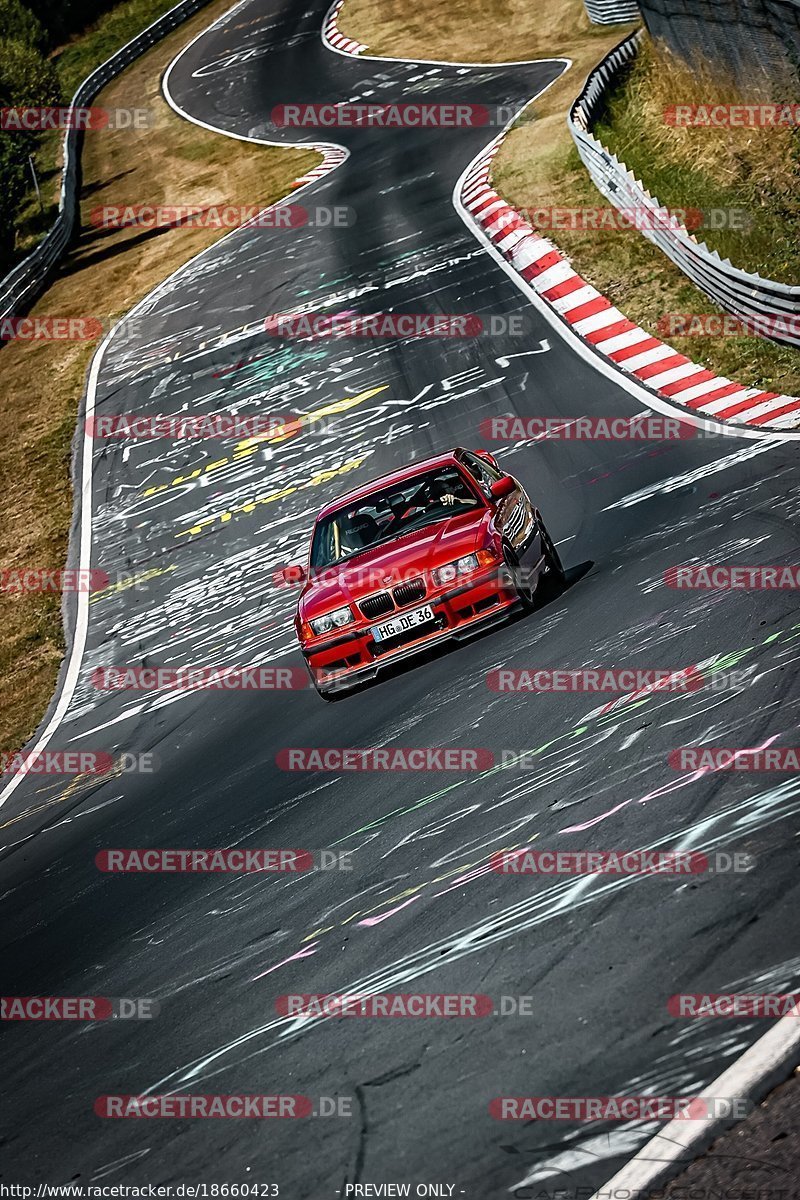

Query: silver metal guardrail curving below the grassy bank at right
[567,31,800,346]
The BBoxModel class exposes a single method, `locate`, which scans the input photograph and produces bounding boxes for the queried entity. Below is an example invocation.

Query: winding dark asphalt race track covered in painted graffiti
[0,0,800,1200]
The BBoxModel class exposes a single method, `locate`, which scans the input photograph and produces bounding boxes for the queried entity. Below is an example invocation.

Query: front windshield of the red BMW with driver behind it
[311,466,482,570]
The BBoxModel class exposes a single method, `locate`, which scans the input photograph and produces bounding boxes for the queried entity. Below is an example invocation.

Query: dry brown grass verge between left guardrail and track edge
[0,0,320,750]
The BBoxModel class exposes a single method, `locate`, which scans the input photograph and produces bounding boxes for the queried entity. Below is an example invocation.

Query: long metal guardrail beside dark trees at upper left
[0,0,209,319]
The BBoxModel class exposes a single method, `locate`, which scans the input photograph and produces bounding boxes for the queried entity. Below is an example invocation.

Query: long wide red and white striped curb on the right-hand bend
[459,144,800,431]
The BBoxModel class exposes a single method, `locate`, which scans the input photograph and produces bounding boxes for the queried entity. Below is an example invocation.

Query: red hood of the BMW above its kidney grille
[300,509,492,619]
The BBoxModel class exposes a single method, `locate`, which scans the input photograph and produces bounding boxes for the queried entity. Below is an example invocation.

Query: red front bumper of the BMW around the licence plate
[302,566,521,691]
